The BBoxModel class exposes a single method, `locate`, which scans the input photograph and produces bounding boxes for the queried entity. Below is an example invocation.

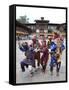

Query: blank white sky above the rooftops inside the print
[16,6,66,23]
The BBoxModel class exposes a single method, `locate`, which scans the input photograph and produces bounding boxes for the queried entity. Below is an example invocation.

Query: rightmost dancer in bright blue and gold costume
[50,34,64,76]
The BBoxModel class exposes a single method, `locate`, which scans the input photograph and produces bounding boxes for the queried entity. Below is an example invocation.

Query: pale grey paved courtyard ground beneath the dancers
[16,40,66,83]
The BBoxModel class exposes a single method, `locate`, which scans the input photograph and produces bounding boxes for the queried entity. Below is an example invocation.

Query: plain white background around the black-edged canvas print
[0,0,69,90]
